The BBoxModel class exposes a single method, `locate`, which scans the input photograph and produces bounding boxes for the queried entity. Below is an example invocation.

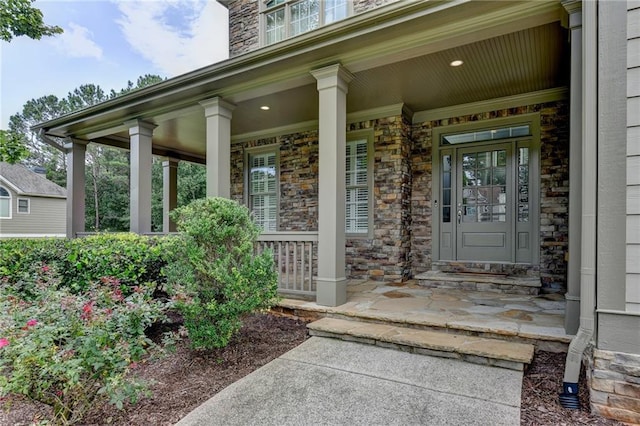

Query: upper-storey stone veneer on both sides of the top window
[229,0,397,57]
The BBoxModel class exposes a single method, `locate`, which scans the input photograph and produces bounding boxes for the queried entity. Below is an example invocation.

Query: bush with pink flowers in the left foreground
[0,268,168,424]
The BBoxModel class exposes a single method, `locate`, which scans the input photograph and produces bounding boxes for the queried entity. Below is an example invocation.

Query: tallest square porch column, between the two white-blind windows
[311,64,353,306]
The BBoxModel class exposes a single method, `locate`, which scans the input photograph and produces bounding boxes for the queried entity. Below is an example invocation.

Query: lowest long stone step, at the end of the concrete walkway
[307,318,534,371]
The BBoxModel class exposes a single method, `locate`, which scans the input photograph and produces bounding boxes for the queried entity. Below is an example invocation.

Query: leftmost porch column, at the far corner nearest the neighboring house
[64,140,88,238]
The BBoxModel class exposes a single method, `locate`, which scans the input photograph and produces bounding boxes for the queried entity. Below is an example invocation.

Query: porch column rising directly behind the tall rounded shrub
[200,97,236,198]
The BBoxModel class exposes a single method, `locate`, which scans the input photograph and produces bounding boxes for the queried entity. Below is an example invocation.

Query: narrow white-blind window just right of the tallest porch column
[345,139,371,235]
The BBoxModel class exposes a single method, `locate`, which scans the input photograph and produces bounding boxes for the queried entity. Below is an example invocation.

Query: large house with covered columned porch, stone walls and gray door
[36,0,640,421]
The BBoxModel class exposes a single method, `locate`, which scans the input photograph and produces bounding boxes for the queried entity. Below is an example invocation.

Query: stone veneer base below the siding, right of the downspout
[587,349,640,424]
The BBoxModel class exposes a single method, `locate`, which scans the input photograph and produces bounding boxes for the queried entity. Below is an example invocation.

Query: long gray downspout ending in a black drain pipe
[560,1,598,409]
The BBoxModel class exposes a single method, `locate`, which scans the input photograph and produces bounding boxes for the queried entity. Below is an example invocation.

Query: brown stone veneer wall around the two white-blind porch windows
[231,116,411,281]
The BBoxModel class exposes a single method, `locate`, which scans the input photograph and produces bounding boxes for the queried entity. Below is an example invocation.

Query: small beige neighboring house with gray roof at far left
[0,162,67,238]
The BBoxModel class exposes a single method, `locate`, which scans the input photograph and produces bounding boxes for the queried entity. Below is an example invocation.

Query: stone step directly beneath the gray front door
[415,271,542,295]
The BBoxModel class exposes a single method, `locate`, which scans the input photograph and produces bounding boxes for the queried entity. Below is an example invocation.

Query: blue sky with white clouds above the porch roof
[0,0,229,129]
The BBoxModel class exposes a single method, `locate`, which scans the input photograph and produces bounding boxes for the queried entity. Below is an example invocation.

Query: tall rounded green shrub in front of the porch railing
[167,198,277,349]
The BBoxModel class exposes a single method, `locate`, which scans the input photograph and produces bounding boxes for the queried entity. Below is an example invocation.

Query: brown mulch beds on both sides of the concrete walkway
[0,314,620,426]
